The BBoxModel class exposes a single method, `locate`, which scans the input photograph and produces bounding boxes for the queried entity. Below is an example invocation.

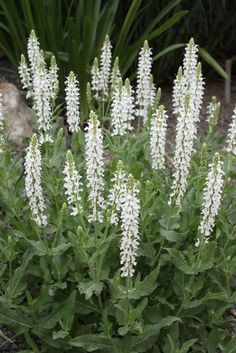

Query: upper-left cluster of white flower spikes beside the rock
[19,30,59,142]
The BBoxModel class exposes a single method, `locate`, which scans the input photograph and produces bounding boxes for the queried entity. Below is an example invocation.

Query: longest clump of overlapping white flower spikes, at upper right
[169,39,203,205]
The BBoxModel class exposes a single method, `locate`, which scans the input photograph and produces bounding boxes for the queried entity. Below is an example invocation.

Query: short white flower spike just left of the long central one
[63,151,83,216]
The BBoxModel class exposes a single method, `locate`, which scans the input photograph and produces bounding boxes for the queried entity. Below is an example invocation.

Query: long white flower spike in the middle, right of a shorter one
[85,111,105,222]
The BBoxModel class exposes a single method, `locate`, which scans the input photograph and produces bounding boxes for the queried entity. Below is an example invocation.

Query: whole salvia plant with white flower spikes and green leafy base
[0,32,236,353]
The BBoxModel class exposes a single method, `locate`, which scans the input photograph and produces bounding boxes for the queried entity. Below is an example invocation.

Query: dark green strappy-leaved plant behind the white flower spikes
[0,0,187,112]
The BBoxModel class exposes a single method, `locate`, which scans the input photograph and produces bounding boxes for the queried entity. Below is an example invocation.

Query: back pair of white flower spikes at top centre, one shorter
[91,35,112,99]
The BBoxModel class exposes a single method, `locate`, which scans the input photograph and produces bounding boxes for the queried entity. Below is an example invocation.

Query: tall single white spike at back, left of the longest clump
[136,41,155,124]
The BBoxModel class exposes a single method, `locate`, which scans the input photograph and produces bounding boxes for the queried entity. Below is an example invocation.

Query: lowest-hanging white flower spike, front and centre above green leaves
[120,175,140,277]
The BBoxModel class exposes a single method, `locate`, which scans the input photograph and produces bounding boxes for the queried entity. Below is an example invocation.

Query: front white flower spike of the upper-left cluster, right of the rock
[33,56,52,143]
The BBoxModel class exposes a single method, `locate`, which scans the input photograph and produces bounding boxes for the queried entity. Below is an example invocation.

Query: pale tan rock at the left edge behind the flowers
[0,82,33,145]
